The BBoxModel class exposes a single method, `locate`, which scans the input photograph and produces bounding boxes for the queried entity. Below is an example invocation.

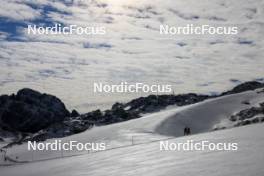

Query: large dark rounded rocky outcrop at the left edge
[0,89,70,133]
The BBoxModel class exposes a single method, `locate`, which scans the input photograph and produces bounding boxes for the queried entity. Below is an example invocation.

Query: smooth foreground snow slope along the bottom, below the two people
[0,124,264,176]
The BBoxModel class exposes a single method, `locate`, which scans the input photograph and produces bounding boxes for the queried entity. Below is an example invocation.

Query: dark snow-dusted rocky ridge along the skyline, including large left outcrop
[0,81,264,142]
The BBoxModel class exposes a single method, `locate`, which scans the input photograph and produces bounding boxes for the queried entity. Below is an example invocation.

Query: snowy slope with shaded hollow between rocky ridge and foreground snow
[2,90,264,164]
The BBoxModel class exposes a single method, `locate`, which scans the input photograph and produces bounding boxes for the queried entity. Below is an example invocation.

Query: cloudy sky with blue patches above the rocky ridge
[0,0,264,112]
